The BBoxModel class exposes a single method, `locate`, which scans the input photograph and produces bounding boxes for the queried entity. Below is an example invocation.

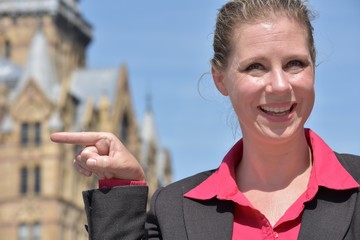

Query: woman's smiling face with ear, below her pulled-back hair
[212,17,315,141]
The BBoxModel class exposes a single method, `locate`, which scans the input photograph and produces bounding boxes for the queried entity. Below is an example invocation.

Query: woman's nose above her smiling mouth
[266,70,291,95]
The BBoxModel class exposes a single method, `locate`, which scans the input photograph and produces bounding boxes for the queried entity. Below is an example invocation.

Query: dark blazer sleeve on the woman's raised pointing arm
[83,186,148,240]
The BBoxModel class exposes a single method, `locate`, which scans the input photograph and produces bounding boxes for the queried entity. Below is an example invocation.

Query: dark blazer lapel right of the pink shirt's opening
[298,188,357,240]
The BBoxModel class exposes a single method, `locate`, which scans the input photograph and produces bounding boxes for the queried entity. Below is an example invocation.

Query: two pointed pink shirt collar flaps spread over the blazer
[184,129,360,200]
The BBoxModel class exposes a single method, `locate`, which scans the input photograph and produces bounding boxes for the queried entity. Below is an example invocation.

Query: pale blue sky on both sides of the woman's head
[80,0,360,180]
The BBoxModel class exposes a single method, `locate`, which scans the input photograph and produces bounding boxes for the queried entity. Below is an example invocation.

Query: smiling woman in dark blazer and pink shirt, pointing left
[51,0,360,240]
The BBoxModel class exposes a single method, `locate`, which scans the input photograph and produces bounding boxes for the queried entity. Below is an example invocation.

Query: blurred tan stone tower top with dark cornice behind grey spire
[0,0,92,80]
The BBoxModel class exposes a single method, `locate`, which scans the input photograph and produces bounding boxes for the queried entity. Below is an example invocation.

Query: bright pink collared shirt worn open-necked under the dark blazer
[184,129,360,240]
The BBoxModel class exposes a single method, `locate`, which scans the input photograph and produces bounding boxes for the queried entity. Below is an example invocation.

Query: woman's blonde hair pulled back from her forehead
[211,0,316,70]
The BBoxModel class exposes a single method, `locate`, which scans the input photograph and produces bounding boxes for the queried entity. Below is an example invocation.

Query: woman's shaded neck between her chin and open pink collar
[236,128,311,192]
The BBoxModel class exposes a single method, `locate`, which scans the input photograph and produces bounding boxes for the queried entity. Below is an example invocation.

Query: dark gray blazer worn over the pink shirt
[83,154,360,240]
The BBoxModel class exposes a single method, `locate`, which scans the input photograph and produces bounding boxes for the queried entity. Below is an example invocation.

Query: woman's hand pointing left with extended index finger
[50,132,145,181]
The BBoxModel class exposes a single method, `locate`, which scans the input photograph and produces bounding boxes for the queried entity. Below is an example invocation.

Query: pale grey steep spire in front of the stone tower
[11,28,60,101]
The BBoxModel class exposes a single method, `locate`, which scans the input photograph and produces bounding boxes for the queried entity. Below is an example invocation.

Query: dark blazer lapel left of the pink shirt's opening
[183,198,234,240]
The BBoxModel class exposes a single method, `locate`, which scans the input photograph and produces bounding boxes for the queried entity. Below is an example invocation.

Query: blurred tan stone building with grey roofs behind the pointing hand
[0,0,172,240]
